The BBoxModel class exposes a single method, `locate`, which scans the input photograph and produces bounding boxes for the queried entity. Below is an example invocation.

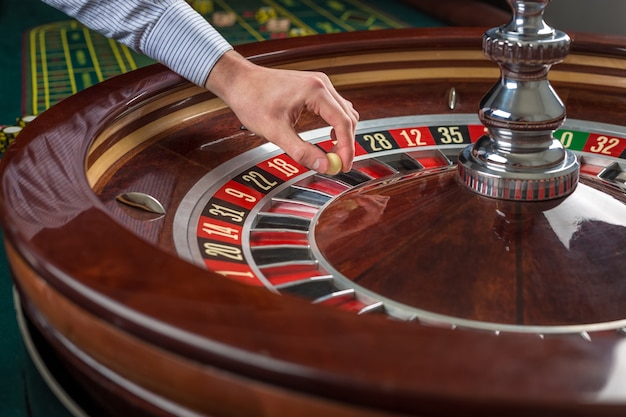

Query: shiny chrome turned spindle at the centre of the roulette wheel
[459,0,579,201]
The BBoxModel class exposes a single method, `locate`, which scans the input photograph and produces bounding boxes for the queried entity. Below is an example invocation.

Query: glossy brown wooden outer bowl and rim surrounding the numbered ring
[0,28,626,416]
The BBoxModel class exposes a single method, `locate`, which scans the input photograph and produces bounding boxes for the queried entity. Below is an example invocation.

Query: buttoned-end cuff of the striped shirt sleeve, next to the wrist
[141,1,233,86]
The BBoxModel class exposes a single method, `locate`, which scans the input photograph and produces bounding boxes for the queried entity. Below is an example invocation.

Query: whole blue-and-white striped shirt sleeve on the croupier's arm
[42,0,232,86]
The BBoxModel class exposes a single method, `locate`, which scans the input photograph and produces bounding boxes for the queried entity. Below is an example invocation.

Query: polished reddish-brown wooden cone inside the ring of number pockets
[316,168,626,329]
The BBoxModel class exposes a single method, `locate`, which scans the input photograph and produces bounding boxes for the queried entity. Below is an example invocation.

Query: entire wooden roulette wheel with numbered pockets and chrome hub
[0,2,626,416]
